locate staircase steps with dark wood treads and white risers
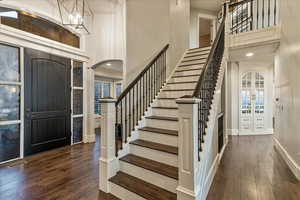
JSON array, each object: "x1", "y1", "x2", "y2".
[{"x1": 109, "y1": 47, "x2": 210, "y2": 200}]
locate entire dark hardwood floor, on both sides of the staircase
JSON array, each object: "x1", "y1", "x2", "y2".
[{"x1": 0, "y1": 132, "x2": 300, "y2": 200}]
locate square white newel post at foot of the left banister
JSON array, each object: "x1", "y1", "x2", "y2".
[{"x1": 99, "y1": 99, "x2": 117, "y2": 193}]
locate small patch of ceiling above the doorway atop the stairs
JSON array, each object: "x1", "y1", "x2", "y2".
[{"x1": 191, "y1": 0, "x2": 223, "y2": 12}]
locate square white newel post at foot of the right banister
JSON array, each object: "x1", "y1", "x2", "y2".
[{"x1": 176, "y1": 97, "x2": 200, "y2": 200}]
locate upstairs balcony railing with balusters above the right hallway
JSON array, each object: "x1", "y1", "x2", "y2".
[{"x1": 229, "y1": 0, "x2": 279, "y2": 34}]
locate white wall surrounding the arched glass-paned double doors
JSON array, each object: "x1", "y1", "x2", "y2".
[{"x1": 227, "y1": 61, "x2": 274, "y2": 135}]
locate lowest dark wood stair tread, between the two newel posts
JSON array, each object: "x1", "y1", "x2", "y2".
[{"x1": 109, "y1": 172, "x2": 177, "y2": 200}]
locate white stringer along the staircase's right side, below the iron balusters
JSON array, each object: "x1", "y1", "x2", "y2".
[{"x1": 196, "y1": 58, "x2": 227, "y2": 200}]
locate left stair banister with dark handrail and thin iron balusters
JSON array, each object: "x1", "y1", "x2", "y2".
[{"x1": 115, "y1": 45, "x2": 169, "y2": 155}]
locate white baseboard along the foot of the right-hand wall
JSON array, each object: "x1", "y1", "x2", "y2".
[{"x1": 273, "y1": 137, "x2": 300, "y2": 181}]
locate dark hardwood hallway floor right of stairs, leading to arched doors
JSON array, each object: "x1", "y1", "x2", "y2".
[{"x1": 207, "y1": 136, "x2": 300, "y2": 200}]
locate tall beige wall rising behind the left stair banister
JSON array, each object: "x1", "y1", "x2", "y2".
[{"x1": 125, "y1": 0, "x2": 190, "y2": 84}]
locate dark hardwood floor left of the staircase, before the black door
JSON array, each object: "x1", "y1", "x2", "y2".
[{"x1": 0, "y1": 133, "x2": 116, "y2": 200}]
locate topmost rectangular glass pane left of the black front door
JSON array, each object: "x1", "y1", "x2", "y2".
[{"x1": 0, "y1": 44, "x2": 20, "y2": 82}]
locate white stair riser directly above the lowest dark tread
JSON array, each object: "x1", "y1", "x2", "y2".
[{"x1": 120, "y1": 161, "x2": 178, "y2": 193}]
